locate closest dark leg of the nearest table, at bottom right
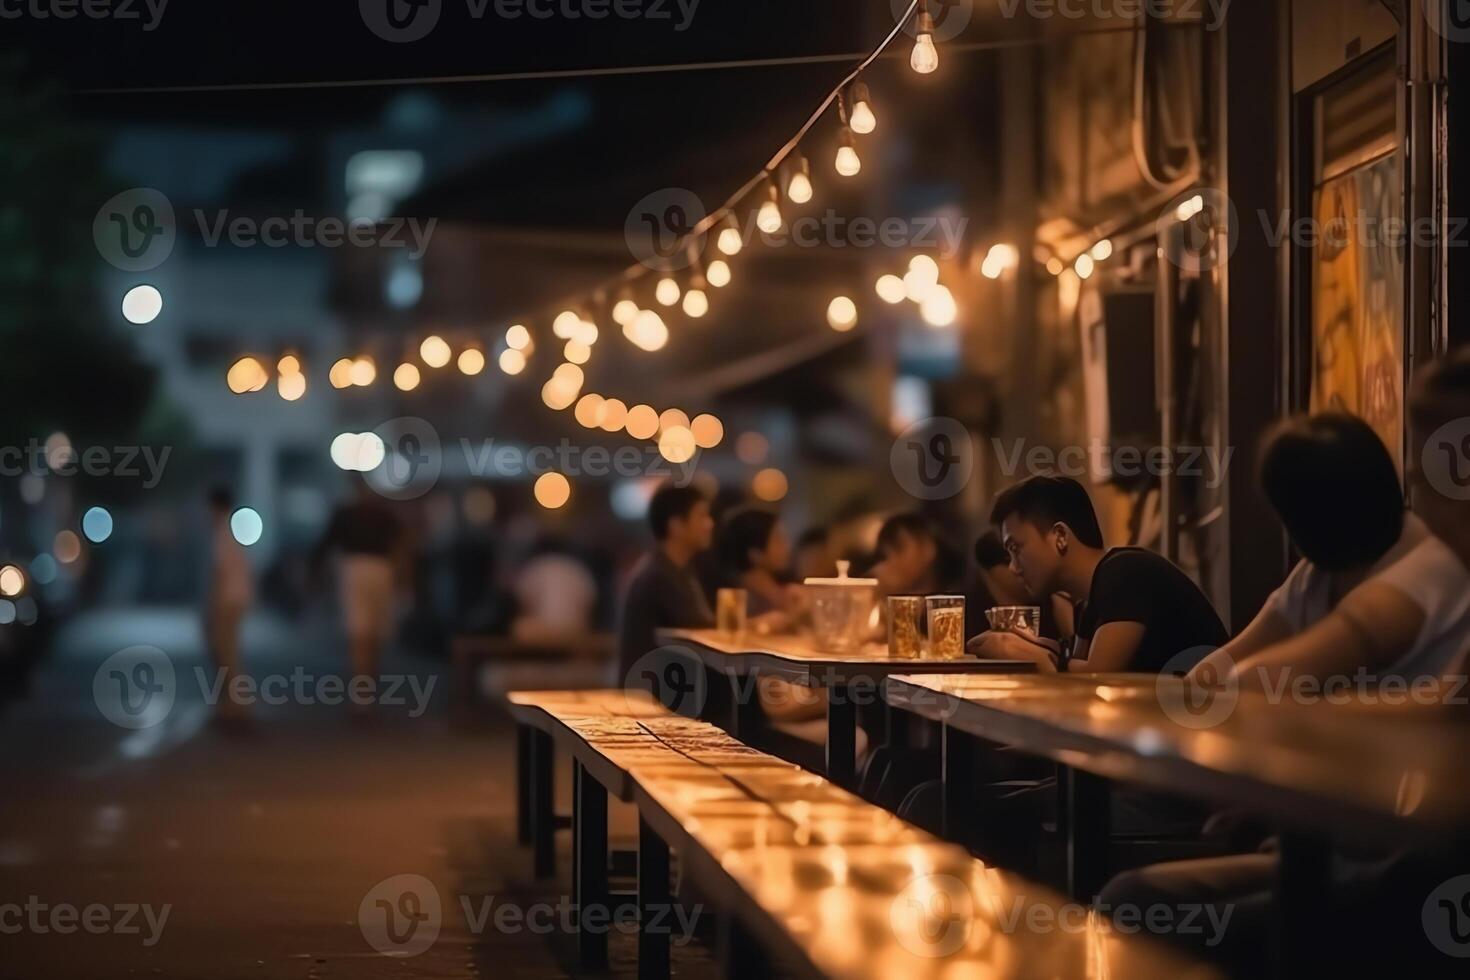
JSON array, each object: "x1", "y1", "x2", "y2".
[{"x1": 1274, "y1": 830, "x2": 1332, "y2": 977}]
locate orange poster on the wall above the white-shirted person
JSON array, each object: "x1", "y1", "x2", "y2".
[{"x1": 1311, "y1": 154, "x2": 1404, "y2": 469}]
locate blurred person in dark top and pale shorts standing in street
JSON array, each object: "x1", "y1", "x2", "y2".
[{"x1": 313, "y1": 479, "x2": 404, "y2": 705}]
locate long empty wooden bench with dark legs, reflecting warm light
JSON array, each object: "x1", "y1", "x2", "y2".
[{"x1": 512, "y1": 692, "x2": 1214, "y2": 980}]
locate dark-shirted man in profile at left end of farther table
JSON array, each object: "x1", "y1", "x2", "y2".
[{"x1": 617, "y1": 483, "x2": 714, "y2": 677}]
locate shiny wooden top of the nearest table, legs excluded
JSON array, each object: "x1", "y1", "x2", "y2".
[{"x1": 883, "y1": 674, "x2": 1470, "y2": 842}]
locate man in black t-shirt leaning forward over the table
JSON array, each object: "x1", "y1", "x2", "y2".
[{"x1": 970, "y1": 476, "x2": 1229, "y2": 673}]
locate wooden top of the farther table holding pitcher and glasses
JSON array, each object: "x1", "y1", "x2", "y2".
[{"x1": 659, "y1": 629, "x2": 1036, "y2": 688}]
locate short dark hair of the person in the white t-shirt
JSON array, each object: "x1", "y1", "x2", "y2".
[{"x1": 1258, "y1": 411, "x2": 1404, "y2": 570}]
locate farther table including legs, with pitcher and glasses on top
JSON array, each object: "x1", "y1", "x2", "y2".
[{"x1": 659, "y1": 629, "x2": 1035, "y2": 789}]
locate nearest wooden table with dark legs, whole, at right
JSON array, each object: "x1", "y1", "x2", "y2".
[{"x1": 883, "y1": 674, "x2": 1470, "y2": 973}]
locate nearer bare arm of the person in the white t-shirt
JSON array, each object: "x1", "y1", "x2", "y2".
[{"x1": 1233, "y1": 580, "x2": 1426, "y2": 689}]
